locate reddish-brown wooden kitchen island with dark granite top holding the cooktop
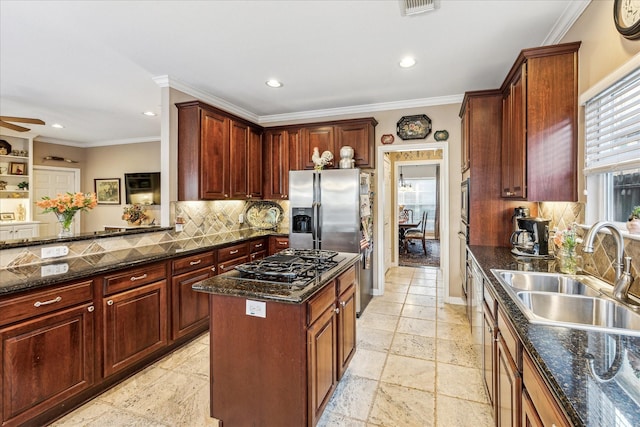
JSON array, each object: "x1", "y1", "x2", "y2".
[{"x1": 193, "y1": 253, "x2": 360, "y2": 426}]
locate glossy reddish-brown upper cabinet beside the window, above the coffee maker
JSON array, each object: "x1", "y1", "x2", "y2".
[{"x1": 501, "y1": 42, "x2": 580, "y2": 201}]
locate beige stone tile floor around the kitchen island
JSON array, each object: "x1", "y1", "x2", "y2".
[{"x1": 53, "y1": 267, "x2": 494, "y2": 427}]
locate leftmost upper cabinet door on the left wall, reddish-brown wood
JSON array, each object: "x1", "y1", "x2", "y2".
[{"x1": 200, "y1": 110, "x2": 231, "y2": 200}]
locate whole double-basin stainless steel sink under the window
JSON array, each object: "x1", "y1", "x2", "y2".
[{"x1": 491, "y1": 270, "x2": 640, "y2": 336}]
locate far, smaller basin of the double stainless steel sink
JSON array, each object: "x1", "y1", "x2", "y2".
[{"x1": 496, "y1": 270, "x2": 601, "y2": 296}]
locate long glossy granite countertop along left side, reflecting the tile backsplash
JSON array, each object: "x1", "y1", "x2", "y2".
[{"x1": 0, "y1": 229, "x2": 288, "y2": 296}]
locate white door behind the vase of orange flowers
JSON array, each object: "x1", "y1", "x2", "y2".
[{"x1": 33, "y1": 166, "x2": 81, "y2": 237}]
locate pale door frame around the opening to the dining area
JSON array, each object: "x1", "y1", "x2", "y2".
[{"x1": 374, "y1": 142, "x2": 449, "y2": 301}]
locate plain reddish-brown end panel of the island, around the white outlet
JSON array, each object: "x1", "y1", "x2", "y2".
[{"x1": 209, "y1": 295, "x2": 309, "y2": 427}]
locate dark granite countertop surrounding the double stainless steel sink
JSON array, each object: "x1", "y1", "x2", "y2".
[{"x1": 469, "y1": 246, "x2": 640, "y2": 427}]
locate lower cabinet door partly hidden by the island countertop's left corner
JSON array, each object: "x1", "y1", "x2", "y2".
[{"x1": 171, "y1": 267, "x2": 214, "y2": 340}]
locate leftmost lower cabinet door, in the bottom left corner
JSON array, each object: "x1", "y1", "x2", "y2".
[{"x1": 0, "y1": 303, "x2": 94, "y2": 425}]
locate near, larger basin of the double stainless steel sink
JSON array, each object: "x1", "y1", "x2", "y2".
[{"x1": 517, "y1": 292, "x2": 640, "y2": 335}]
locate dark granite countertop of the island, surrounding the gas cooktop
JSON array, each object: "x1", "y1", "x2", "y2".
[{"x1": 193, "y1": 252, "x2": 360, "y2": 304}]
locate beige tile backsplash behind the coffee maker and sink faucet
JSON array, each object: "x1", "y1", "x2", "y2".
[{"x1": 538, "y1": 202, "x2": 640, "y2": 298}]
